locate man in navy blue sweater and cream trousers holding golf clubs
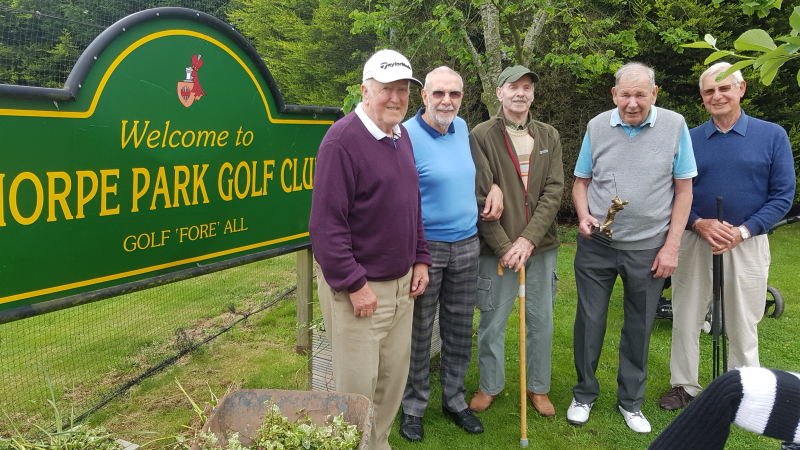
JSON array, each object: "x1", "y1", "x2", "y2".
[{"x1": 659, "y1": 63, "x2": 795, "y2": 410}]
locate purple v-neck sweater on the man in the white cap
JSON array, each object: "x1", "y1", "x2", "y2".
[{"x1": 308, "y1": 113, "x2": 431, "y2": 292}]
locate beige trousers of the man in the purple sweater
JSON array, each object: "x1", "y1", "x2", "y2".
[{"x1": 317, "y1": 270, "x2": 414, "y2": 450}]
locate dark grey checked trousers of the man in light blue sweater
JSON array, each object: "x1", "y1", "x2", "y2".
[{"x1": 403, "y1": 235, "x2": 480, "y2": 417}]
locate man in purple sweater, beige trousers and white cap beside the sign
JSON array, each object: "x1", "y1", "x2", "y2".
[{"x1": 308, "y1": 50, "x2": 431, "y2": 450}]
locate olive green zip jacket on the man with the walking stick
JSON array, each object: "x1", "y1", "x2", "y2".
[{"x1": 469, "y1": 111, "x2": 564, "y2": 257}]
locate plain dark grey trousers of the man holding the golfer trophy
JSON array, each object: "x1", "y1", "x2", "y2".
[{"x1": 572, "y1": 236, "x2": 664, "y2": 412}]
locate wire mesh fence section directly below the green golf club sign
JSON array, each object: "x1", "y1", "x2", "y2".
[{"x1": 0, "y1": 254, "x2": 296, "y2": 435}]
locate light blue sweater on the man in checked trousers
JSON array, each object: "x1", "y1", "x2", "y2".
[{"x1": 403, "y1": 108, "x2": 478, "y2": 242}]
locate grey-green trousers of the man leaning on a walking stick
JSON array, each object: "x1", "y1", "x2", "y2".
[{"x1": 478, "y1": 249, "x2": 558, "y2": 395}]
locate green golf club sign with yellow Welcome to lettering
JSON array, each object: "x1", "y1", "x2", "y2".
[{"x1": 0, "y1": 8, "x2": 338, "y2": 311}]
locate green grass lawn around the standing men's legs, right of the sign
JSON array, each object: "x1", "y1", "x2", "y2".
[{"x1": 389, "y1": 226, "x2": 800, "y2": 450}]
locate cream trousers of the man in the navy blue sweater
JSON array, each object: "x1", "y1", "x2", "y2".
[{"x1": 669, "y1": 231, "x2": 770, "y2": 396}]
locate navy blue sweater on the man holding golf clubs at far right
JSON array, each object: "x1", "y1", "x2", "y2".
[{"x1": 686, "y1": 111, "x2": 795, "y2": 236}]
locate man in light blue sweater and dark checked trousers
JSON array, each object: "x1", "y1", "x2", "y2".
[{"x1": 400, "y1": 66, "x2": 502, "y2": 442}]
